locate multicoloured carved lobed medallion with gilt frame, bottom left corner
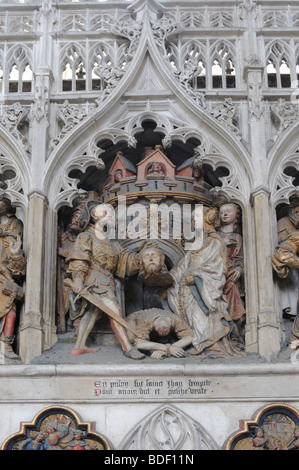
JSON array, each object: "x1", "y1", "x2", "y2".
[{"x1": 0, "y1": 406, "x2": 112, "y2": 450}]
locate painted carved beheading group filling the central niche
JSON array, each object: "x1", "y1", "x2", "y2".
[{"x1": 52, "y1": 151, "x2": 245, "y2": 359}]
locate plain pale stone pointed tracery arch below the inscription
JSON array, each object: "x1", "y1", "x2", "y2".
[{"x1": 120, "y1": 405, "x2": 218, "y2": 451}]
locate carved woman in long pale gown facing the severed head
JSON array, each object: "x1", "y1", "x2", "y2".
[{"x1": 168, "y1": 209, "x2": 242, "y2": 356}]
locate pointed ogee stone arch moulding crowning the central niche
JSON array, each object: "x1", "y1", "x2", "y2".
[{"x1": 45, "y1": 1, "x2": 254, "y2": 201}]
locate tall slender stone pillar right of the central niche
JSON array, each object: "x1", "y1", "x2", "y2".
[{"x1": 244, "y1": 10, "x2": 281, "y2": 360}]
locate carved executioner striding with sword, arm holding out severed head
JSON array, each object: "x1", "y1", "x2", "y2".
[{"x1": 65, "y1": 201, "x2": 144, "y2": 359}]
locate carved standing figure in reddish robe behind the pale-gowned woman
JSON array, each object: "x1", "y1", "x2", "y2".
[{"x1": 218, "y1": 204, "x2": 245, "y2": 339}]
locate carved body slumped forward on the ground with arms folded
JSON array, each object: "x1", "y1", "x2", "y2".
[{"x1": 128, "y1": 308, "x2": 194, "y2": 359}]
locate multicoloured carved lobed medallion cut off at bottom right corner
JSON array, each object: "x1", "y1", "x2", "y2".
[{"x1": 222, "y1": 403, "x2": 299, "y2": 450}]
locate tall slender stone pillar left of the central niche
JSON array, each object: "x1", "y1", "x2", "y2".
[{"x1": 19, "y1": 0, "x2": 56, "y2": 363}]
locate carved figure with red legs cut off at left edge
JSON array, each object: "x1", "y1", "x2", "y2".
[{"x1": 0, "y1": 196, "x2": 26, "y2": 359}]
